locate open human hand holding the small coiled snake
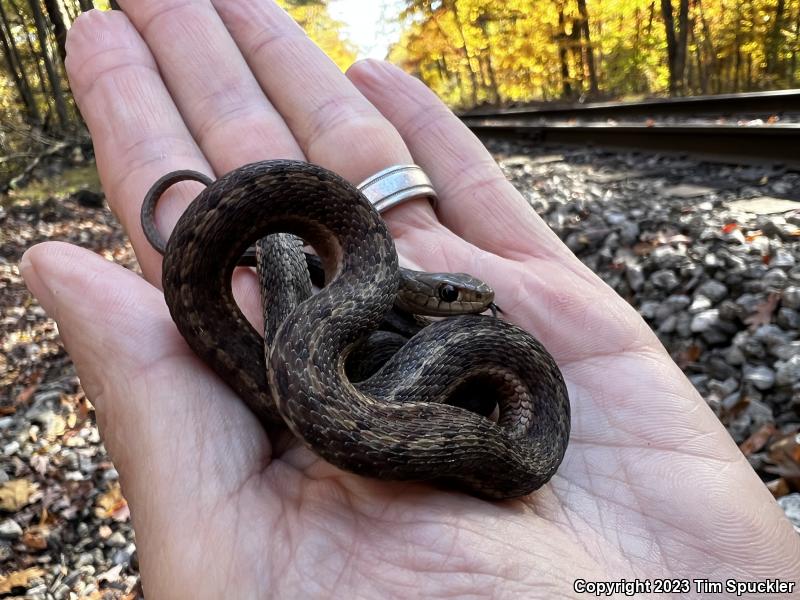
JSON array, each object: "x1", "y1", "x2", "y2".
[{"x1": 22, "y1": 0, "x2": 800, "y2": 598}]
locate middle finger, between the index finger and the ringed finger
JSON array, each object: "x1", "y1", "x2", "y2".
[{"x1": 120, "y1": 0, "x2": 303, "y2": 174}]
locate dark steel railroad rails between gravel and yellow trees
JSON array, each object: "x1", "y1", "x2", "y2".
[{"x1": 462, "y1": 90, "x2": 800, "y2": 169}]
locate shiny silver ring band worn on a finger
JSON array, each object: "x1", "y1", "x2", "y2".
[{"x1": 358, "y1": 165, "x2": 438, "y2": 213}]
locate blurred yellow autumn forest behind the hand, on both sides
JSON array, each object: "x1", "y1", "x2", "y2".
[{"x1": 0, "y1": 0, "x2": 800, "y2": 193}]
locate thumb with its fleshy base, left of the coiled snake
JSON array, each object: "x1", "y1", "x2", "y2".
[{"x1": 20, "y1": 242, "x2": 269, "y2": 548}]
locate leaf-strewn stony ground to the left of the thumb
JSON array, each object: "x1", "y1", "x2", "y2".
[{"x1": 0, "y1": 166, "x2": 139, "y2": 600}]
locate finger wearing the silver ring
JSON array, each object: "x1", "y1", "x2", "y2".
[{"x1": 213, "y1": 0, "x2": 435, "y2": 230}]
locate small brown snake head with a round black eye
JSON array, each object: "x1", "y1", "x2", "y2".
[{"x1": 395, "y1": 271, "x2": 494, "y2": 317}]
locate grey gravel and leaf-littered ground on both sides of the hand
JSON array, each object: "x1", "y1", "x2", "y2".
[{"x1": 0, "y1": 142, "x2": 800, "y2": 600}]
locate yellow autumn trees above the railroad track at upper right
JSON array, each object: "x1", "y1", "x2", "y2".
[{"x1": 390, "y1": 0, "x2": 800, "y2": 107}]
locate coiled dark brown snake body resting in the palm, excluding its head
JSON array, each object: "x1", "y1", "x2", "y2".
[{"x1": 142, "y1": 160, "x2": 570, "y2": 500}]
